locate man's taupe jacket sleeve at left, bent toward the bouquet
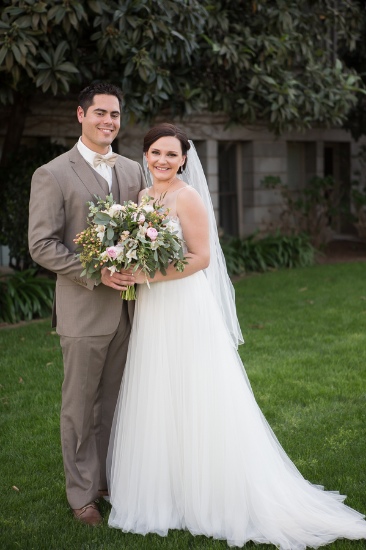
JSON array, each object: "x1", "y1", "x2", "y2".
[{"x1": 28, "y1": 166, "x2": 94, "y2": 290}]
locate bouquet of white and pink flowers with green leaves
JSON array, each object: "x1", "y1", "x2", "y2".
[{"x1": 74, "y1": 194, "x2": 187, "y2": 300}]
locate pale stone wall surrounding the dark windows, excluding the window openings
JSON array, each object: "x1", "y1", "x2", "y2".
[{"x1": 0, "y1": 97, "x2": 366, "y2": 250}]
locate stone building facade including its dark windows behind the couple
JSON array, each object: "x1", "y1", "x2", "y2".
[{"x1": 0, "y1": 99, "x2": 366, "y2": 265}]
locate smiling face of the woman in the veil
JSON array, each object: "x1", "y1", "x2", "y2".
[{"x1": 146, "y1": 136, "x2": 185, "y2": 183}]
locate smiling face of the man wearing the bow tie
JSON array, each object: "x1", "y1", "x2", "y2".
[{"x1": 77, "y1": 94, "x2": 121, "y2": 155}]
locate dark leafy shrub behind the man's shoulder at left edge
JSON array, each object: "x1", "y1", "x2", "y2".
[{"x1": 0, "y1": 140, "x2": 67, "y2": 270}]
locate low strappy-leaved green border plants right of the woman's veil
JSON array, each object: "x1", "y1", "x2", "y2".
[{"x1": 221, "y1": 233, "x2": 315, "y2": 276}]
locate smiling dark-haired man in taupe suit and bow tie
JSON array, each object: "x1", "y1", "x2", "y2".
[{"x1": 29, "y1": 83, "x2": 145, "y2": 525}]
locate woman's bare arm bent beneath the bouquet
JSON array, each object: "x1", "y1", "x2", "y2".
[{"x1": 135, "y1": 187, "x2": 210, "y2": 283}]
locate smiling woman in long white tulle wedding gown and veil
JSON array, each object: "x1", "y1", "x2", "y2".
[{"x1": 108, "y1": 124, "x2": 366, "y2": 550}]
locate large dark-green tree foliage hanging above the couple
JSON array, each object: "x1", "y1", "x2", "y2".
[{"x1": 0, "y1": 0, "x2": 366, "y2": 170}]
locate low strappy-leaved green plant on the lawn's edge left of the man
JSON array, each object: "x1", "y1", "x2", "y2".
[{"x1": 0, "y1": 269, "x2": 55, "y2": 323}]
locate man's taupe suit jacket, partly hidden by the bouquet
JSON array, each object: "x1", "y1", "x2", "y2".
[{"x1": 29, "y1": 145, "x2": 145, "y2": 337}]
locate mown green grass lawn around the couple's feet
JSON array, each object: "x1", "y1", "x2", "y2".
[{"x1": 0, "y1": 263, "x2": 366, "y2": 550}]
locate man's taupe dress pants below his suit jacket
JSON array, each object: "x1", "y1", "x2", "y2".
[{"x1": 60, "y1": 302, "x2": 131, "y2": 508}]
